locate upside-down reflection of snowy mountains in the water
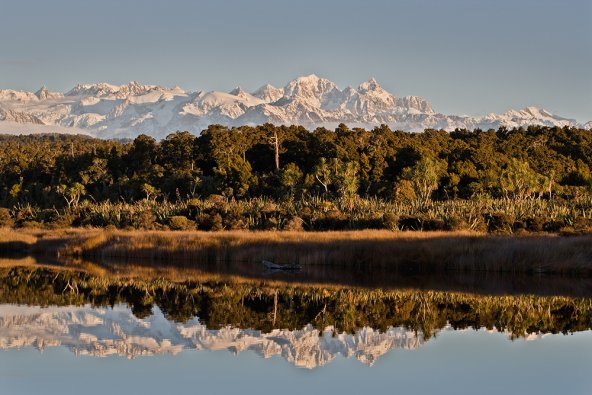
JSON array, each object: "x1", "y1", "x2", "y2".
[{"x1": 0, "y1": 304, "x2": 424, "y2": 369}]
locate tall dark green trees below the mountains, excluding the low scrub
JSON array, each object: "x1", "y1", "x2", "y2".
[{"x1": 0, "y1": 124, "x2": 592, "y2": 232}]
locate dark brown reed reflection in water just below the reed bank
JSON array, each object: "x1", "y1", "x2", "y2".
[{"x1": 0, "y1": 256, "x2": 592, "y2": 297}]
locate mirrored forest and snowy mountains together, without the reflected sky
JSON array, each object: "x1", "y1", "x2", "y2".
[{"x1": 0, "y1": 266, "x2": 592, "y2": 368}]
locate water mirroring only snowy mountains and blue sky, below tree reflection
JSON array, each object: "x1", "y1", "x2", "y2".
[{"x1": 0, "y1": 305, "x2": 592, "y2": 394}]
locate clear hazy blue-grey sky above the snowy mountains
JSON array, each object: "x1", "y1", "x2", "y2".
[{"x1": 0, "y1": 0, "x2": 592, "y2": 121}]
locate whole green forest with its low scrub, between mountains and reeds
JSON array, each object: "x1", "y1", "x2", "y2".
[{"x1": 0, "y1": 124, "x2": 592, "y2": 233}]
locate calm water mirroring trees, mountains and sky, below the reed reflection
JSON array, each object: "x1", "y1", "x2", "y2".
[{"x1": 0, "y1": 262, "x2": 592, "y2": 394}]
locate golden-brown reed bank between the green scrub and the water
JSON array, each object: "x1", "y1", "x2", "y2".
[{"x1": 0, "y1": 229, "x2": 592, "y2": 276}]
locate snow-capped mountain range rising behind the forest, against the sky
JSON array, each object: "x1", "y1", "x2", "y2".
[{"x1": 0, "y1": 74, "x2": 592, "y2": 138}]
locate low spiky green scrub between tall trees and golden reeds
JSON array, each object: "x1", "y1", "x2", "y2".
[{"x1": 0, "y1": 195, "x2": 592, "y2": 235}]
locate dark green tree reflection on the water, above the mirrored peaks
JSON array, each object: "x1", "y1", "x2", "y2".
[{"x1": 0, "y1": 267, "x2": 592, "y2": 339}]
